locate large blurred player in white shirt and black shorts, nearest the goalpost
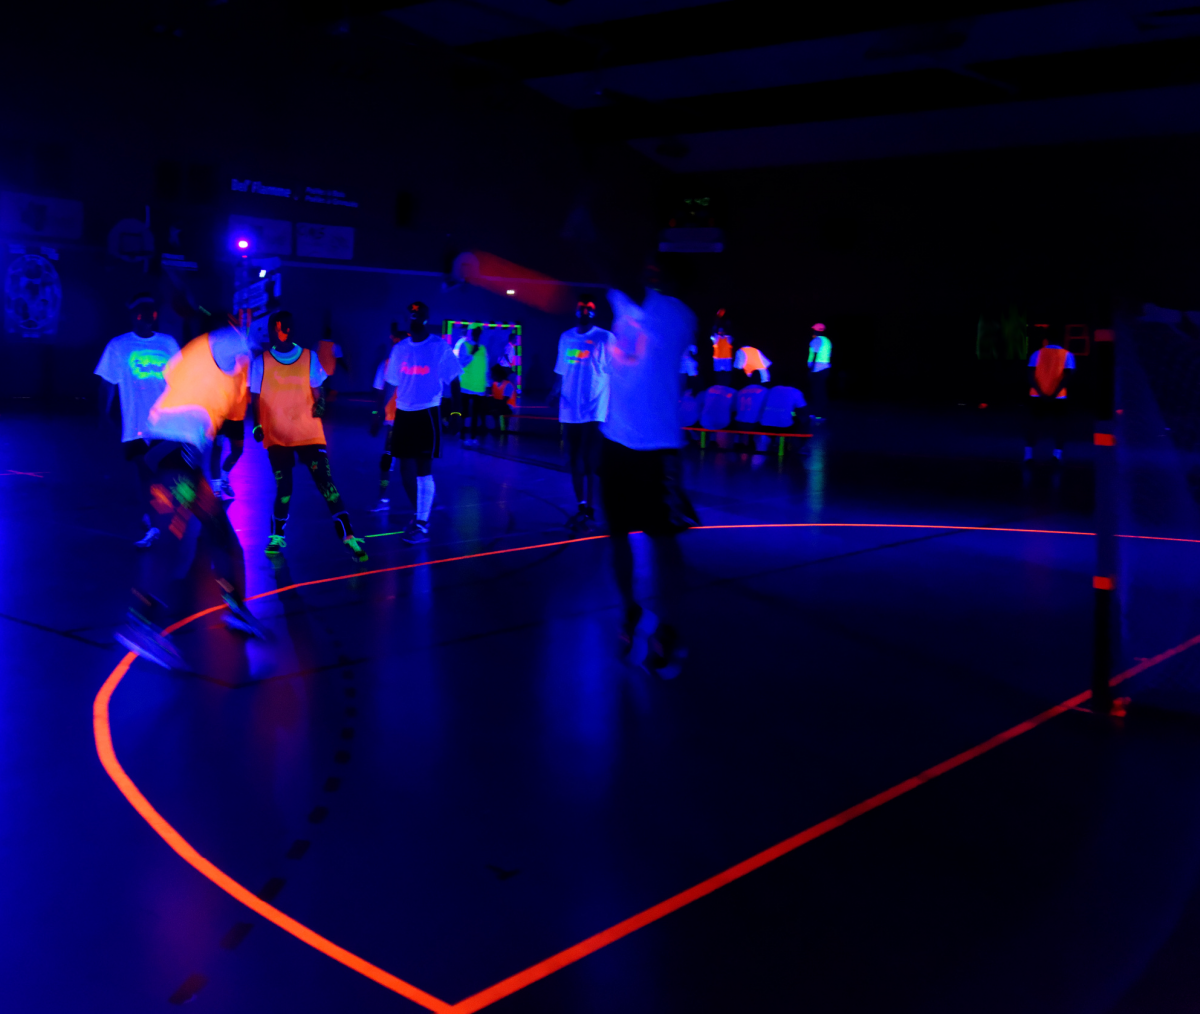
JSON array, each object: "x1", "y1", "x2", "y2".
[{"x1": 600, "y1": 255, "x2": 698, "y2": 679}]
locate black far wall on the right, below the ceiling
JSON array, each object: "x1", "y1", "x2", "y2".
[{"x1": 686, "y1": 129, "x2": 1200, "y2": 403}]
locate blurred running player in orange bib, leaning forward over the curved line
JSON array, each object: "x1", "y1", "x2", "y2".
[{"x1": 114, "y1": 307, "x2": 265, "y2": 668}]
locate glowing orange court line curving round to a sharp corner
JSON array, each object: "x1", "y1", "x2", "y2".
[{"x1": 92, "y1": 522, "x2": 1200, "y2": 1014}]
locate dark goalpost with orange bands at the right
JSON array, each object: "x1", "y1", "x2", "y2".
[{"x1": 1092, "y1": 330, "x2": 1117, "y2": 715}]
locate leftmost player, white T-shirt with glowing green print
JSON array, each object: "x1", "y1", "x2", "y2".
[{"x1": 95, "y1": 293, "x2": 179, "y2": 550}]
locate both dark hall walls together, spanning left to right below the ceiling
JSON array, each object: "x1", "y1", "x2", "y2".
[{"x1": 7, "y1": 0, "x2": 1200, "y2": 403}]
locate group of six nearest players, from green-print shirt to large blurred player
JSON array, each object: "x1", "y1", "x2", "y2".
[{"x1": 96, "y1": 265, "x2": 696, "y2": 678}]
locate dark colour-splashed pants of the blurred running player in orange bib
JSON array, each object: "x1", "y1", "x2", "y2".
[{"x1": 134, "y1": 444, "x2": 246, "y2": 625}]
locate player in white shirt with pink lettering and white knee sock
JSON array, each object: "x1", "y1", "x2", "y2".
[{"x1": 371, "y1": 302, "x2": 462, "y2": 544}]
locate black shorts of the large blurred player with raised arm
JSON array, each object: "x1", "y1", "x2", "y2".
[{"x1": 600, "y1": 437, "x2": 700, "y2": 535}]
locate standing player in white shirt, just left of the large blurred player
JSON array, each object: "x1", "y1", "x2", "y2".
[{"x1": 550, "y1": 294, "x2": 612, "y2": 530}]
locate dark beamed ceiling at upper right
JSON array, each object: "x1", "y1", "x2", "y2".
[{"x1": 388, "y1": 0, "x2": 1200, "y2": 170}]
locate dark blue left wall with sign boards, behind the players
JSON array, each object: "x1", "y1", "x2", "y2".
[{"x1": 0, "y1": 2, "x2": 661, "y2": 407}]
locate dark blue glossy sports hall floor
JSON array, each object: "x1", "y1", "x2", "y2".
[{"x1": 7, "y1": 409, "x2": 1200, "y2": 1014}]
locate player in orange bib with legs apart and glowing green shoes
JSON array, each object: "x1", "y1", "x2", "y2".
[{"x1": 250, "y1": 310, "x2": 367, "y2": 563}]
